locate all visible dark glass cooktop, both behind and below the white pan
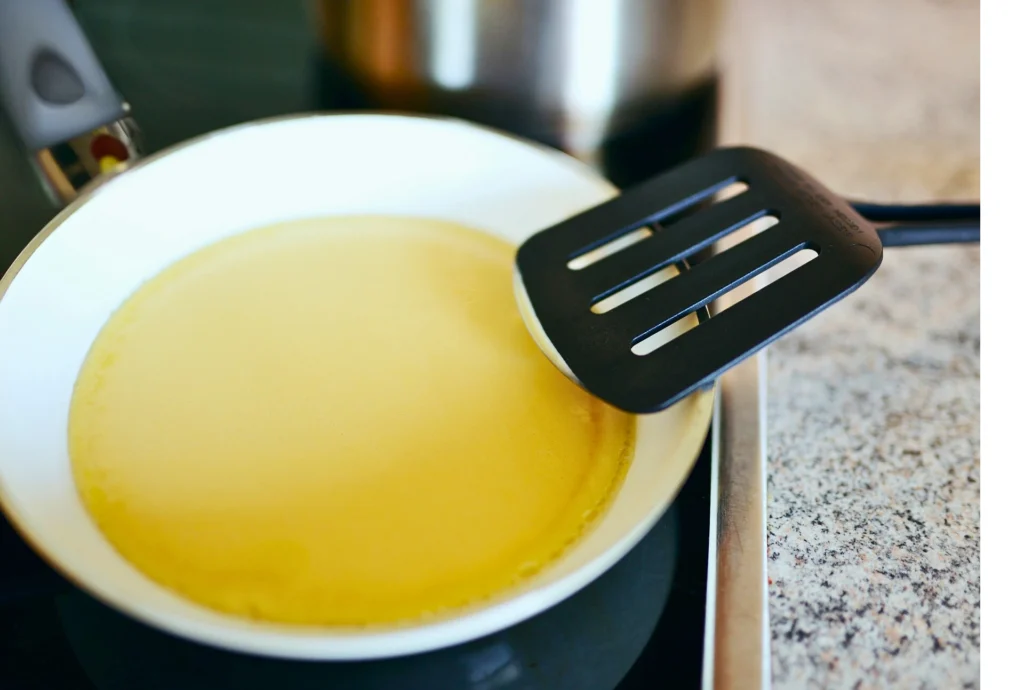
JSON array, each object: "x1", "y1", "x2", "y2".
[{"x1": 0, "y1": 0, "x2": 717, "y2": 690}]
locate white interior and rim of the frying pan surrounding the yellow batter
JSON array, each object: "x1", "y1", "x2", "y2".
[{"x1": 0, "y1": 0, "x2": 713, "y2": 659}]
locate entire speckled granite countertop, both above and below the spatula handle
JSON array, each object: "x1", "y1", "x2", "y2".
[{"x1": 727, "y1": 0, "x2": 981, "y2": 690}]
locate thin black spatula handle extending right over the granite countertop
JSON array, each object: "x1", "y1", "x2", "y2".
[{"x1": 852, "y1": 202, "x2": 981, "y2": 247}]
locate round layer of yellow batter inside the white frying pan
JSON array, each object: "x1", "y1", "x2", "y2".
[{"x1": 69, "y1": 217, "x2": 634, "y2": 624}]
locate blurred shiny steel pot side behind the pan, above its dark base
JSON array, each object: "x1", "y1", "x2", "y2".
[{"x1": 315, "y1": 0, "x2": 719, "y2": 160}]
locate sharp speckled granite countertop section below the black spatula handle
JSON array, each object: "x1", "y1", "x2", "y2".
[{"x1": 768, "y1": 243, "x2": 981, "y2": 688}]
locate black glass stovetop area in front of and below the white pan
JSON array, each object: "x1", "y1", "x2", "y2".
[{"x1": 0, "y1": 436, "x2": 712, "y2": 690}]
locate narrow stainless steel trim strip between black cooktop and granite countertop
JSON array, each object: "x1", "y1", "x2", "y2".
[{"x1": 706, "y1": 0, "x2": 771, "y2": 690}]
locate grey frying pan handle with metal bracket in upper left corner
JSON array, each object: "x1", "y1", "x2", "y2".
[{"x1": 0, "y1": 0, "x2": 141, "y2": 204}]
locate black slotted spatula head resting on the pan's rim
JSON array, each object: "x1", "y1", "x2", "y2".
[{"x1": 516, "y1": 147, "x2": 882, "y2": 414}]
